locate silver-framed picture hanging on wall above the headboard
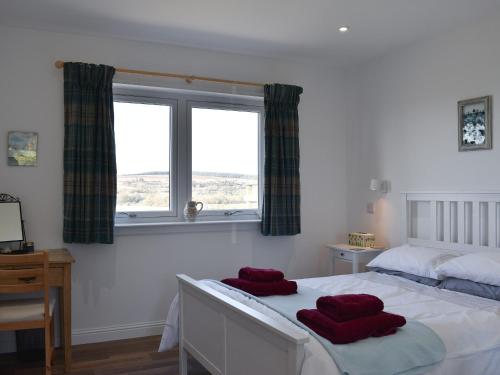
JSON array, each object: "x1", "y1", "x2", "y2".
[{"x1": 458, "y1": 96, "x2": 492, "y2": 151}]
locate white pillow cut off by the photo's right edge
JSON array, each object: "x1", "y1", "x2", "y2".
[{"x1": 436, "y1": 250, "x2": 500, "y2": 286}]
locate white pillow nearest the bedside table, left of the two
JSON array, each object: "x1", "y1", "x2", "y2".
[{"x1": 367, "y1": 245, "x2": 458, "y2": 280}]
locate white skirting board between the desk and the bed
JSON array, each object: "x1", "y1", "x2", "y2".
[{"x1": 72, "y1": 320, "x2": 165, "y2": 345}]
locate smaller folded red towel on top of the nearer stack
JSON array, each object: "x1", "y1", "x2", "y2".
[{"x1": 316, "y1": 294, "x2": 384, "y2": 322}]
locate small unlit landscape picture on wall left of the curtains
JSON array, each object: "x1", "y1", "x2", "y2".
[{"x1": 7, "y1": 131, "x2": 38, "y2": 167}]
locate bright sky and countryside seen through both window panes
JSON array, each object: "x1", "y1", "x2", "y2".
[{"x1": 114, "y1": 102, "x2": 259, "y2": 212}]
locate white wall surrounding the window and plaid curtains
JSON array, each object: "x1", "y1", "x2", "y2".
[{"x1": 0, "y1": 28, "x2": 347, "y2": 348}]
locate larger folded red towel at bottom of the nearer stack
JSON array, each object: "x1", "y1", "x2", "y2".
[{"x1": 297, "y1": 310, "x2": 406, "y2": 344}]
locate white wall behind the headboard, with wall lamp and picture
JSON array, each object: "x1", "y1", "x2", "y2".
[{"x1": 347, "y1": 17, "x2": 500, "y2": 245}]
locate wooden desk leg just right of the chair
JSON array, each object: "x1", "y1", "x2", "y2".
[{"x1": 59, "y1": 265, "x2": 71, "y2": 372}]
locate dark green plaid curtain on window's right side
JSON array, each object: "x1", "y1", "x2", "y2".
[{"x1": 261, "y1": 84, "x2": 302, "y2": 236}]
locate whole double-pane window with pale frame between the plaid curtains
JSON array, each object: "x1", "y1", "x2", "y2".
[{"x1": 114, "y1": 85, "x2": 263, "y2": 224}]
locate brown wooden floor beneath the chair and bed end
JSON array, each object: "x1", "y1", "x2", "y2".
[{"x1": 0, "y1": 336, "x2": 209, "y2": 375}]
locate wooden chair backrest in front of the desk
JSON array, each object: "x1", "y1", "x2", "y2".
[{"x1": 0, "y1": 251, "x2": 49, "y2": 296}]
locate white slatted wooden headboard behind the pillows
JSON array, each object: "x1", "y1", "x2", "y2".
[{"x1": 401, "y1": 192, "x2": 500, "y2": 251}]
